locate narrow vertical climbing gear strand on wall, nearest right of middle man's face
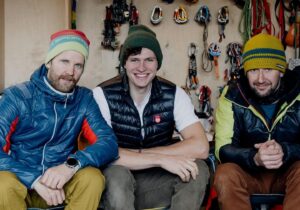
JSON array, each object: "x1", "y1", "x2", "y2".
[{"x1": 186, "y1": 43, "x2": 199, "y2": 90}]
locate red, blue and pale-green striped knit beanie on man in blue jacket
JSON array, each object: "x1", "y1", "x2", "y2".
[{"x1": 45, "y1": 29, "x2": 90, "y2": 64}]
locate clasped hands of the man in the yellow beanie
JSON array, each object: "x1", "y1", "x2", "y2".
[{"x1": 254, "y1": 140, "x2": 284, "y2": 169}]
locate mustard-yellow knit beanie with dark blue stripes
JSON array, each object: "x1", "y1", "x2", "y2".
[{"x1": 243, "y1": 33, "x2": 287, "y2": 73}]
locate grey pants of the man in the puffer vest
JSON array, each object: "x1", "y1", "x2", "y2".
[{"x1": 102, "y1": 160, "x2": 209, "y2": 210}]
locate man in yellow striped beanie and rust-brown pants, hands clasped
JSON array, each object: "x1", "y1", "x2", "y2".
[{"x1": 214, "y1": 34, "x2": 300, "y2": 210}]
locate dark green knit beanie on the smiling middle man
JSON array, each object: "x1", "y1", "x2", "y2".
[{"x1": 119, "y1": 25, "x2": 163, "y2": 70}]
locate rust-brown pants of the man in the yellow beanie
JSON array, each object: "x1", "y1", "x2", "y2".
[{"x1": 214, "y1": 161, "x2": 300, "y2": 210}]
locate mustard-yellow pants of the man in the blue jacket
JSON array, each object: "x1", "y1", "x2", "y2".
[{"x1": 0, "y1": 167, "x2": 105, "y2": 210}]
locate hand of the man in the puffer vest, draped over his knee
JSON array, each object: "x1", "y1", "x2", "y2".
[{"x1": 160, "y1": 155, "x2": 199, "y2": 182}]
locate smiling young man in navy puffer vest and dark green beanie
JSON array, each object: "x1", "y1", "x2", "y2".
[{"x1": 94, "y1": 25, "x2": 209, "y2": 210}]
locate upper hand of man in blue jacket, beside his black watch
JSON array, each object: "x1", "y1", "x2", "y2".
[{"x1": 40, "y1": 164, "x2": 76, "y2": 189}]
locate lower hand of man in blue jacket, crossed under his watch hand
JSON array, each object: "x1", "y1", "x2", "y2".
[{"x1": 34, "y1": 181, "x2": 65, "y2": 206}]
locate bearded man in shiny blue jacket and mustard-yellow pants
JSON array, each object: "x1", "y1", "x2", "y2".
[{"x1": 0, "y1": 30, "x2": 118, "y2": 210}]
